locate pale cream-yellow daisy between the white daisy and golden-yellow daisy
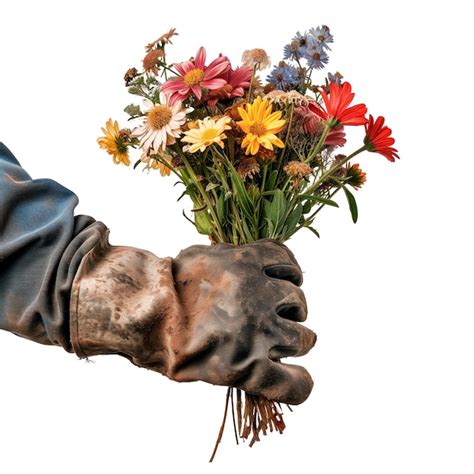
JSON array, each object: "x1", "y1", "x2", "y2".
[{"x1": 181, "y1": 116, "x2": 231, "y2": 153}]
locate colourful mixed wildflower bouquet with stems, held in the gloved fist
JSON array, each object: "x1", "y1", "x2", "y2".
[{"x1": 98, "y1": 26, "x2": 398, "y2": 460}]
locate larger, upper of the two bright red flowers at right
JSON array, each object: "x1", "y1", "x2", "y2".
[{"x1": 309, "y1": 82, "x2": 367, "y2": 128}]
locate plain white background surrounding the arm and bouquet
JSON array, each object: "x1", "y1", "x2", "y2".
[{"x1": 0, "y1": 0, "x2": 474, "y2": 474}]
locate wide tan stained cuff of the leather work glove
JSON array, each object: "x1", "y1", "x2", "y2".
[{"x1": 70, "y1": 231, "x2": 179, "y2": 373}]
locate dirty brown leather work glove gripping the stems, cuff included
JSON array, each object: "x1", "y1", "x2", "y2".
[{"x1": 70, "y1": 233, "x2": 316, "y2": 404}]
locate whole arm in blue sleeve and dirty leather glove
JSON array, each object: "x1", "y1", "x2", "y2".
[{"x1": 0, "y1": 144, "x2": 316, "y2": 404}]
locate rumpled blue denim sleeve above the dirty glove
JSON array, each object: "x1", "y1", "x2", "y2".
[{"x1": 0, "y1": 143, "x2": 107, "y2": 352}]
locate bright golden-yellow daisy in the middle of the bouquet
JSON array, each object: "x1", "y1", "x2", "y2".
[{"x1": 237, "y1": 96, "x2": 285, "y2": 155}]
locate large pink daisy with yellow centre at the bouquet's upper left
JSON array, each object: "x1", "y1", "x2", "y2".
[{"x1": 161, "y1": 46, "x2": 230, "y2": 104}]
